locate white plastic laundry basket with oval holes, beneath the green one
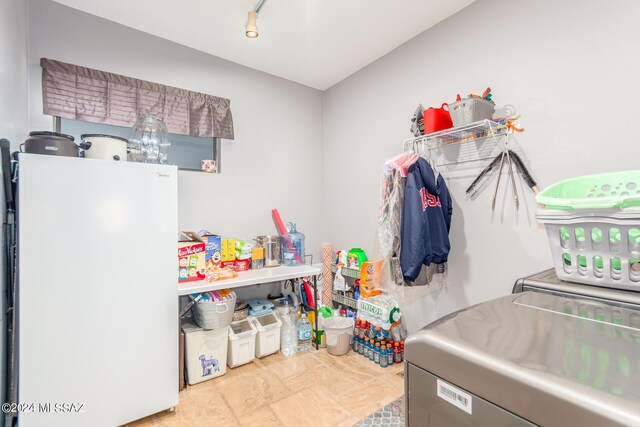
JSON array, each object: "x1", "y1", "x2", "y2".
[{"x1": 536, "y1": 208, "x2": 640, "y2": 291}]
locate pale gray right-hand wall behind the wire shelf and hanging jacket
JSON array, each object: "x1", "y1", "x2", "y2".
[{"x1": 324, "y1": 0, "x2": 640, "y2": 329}]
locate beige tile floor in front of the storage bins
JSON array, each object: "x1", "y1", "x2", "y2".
[{"x1": 127, "y1": 349, "x2": 404, "y2": 427}]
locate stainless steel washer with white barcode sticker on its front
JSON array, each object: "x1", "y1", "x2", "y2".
[{"x1": 405, "y1": 270, "x2": 640, "y2": 427}]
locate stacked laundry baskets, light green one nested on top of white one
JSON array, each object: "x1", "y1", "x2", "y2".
[{"x1": 536, "y1": 171, "x2": 640, "y2": 291}]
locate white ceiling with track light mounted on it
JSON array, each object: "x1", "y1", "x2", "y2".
[{"x1": 50, "y1": 0, "x2": 475, "y2": 90}]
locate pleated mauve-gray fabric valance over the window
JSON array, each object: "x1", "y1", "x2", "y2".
[{"x1": 40, "y1": 58, "x2": 233, "y2": 139}]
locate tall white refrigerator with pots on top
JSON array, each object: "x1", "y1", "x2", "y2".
[{"x1": 17, "y1": 154, "x2": 178, "y2": 427}]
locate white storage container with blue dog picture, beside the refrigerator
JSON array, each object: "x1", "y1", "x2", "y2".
[{"x1": 182, "y1": 320, "x2": 229, "y2": 384}]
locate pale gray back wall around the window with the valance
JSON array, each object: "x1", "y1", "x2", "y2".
[{"x1": 29, "y1": 0, "x2": 324, "y2": 259}]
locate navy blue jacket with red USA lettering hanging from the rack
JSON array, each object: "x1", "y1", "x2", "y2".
[{"x1": 400, "y1": 158, "x2": 452, "y2": 281}]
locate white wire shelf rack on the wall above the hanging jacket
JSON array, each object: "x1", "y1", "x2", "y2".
[{"x1": 404, "y1": 120, "x2": 509, "y2": 166}]
